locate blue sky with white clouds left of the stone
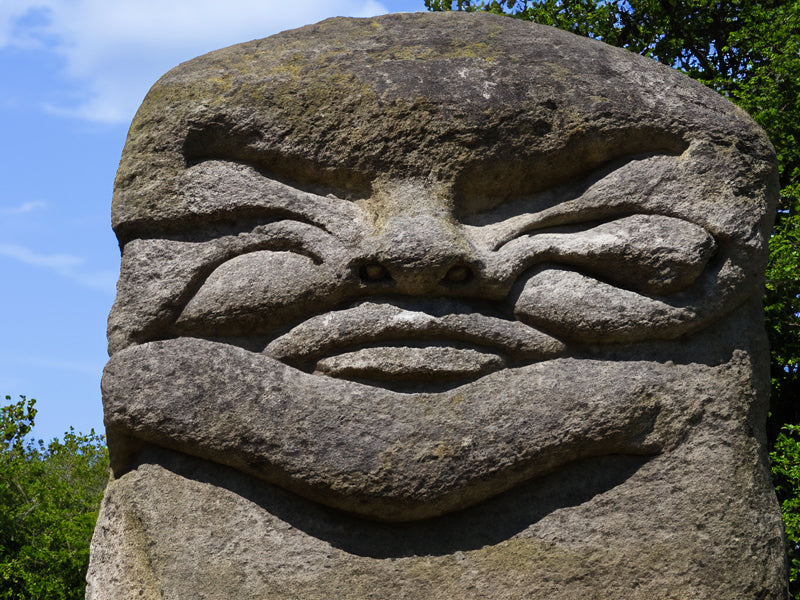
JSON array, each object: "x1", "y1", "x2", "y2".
[{"x1": 0, "y1": 0, "x2": 425, "y2": 440}]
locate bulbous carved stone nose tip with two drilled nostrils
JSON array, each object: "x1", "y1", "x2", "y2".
[{"x1": 359, "y1": 215, "x2": 477, "y2": 294}]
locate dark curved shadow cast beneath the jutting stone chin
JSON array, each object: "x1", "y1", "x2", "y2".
[{"x1": 139, "y1": 447, "x2": 650, "y2": 559}]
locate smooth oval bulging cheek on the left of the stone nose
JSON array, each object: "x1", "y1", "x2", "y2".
[{"x1": 176, "y1": 250, "x2": 346, "y2": 335}]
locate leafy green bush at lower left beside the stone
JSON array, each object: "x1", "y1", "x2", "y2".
[{"x1": 0, "y1": 396, "x2": 108, "y2": 600}]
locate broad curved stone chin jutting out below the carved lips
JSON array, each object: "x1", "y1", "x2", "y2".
[{"x1": 103, "y1": 338, "x2": 687, "y2": 521}]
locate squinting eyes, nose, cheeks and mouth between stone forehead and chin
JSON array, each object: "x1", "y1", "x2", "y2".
[{"x1": 165, "y1": 154, "x2": 720, "y2": 380}]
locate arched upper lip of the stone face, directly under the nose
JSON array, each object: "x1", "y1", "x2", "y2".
[{"x1": 264, "y1": 299, "x2": 565, "y2": 363}]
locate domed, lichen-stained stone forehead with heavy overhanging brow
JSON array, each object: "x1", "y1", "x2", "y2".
[{"x1": 112, "y1": 13, "x2": 770, "y2": 232}]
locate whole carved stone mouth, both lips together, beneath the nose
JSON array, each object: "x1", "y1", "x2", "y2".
[{"x1": 264, "y1": 299, "x2": 565, "y2": 380}]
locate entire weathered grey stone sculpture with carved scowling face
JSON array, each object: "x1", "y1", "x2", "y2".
[{"x1": 87, "y1": 13, "x2": 786, "y2": 600}]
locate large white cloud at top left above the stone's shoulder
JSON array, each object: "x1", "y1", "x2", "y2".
[{"x1": 0, "y1": 0, "x2": 387, "y2": 122}]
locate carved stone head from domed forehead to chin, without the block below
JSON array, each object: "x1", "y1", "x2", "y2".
[{"x1": 104, "y1": 15, "x2": 774, "y2": 520}]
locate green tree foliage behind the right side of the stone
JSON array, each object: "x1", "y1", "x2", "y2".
[{"x1": 432, "y1": 0, "x2": 800, "y2": 600}]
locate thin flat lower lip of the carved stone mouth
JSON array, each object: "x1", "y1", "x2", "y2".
[{"x1": 315, "y1": 346, "x2": 507, "y2": 381}]
